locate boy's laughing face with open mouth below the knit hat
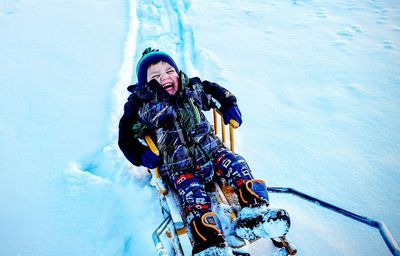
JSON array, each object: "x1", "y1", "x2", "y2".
[{"x1": 147, "y1": 61, "x2": 179, "y2": 95}]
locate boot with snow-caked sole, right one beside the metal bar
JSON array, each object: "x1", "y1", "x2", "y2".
[{"x1": 235, "y1": 180, "x2": 290, "y2": 241}]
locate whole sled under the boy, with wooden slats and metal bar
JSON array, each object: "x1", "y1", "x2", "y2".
[{"x1": 145, "y1": 110, "x2": 400, "y2": 256}]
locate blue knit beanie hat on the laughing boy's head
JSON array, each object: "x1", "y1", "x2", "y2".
[{"x1": 136, "y1": 47, "x2": 179, "y2": 84}]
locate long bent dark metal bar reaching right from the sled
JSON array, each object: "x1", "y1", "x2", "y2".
[{"x1": 268, "y1": 187, "x2": 400, "y2": 256}]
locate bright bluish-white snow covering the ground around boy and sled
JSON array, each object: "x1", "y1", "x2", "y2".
[{"x1": 0, "y1": 0, "x2": 400, "y2": 255}]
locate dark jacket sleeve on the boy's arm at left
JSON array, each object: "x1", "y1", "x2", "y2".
[{"x1": 118, "y1": 95, "x2": 147, "y2": 166}]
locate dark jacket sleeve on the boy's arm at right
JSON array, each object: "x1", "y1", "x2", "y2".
[{"x1": 196, "y1": 78, "x2": 237, "y2": 112}]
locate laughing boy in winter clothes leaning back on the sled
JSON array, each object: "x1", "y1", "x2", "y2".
[{"x1": 118, "y1": 48, "x2": 290, "y2": 255}]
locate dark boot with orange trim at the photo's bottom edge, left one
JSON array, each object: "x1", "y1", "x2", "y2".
[{"x1": 190, "y1": 212, "x2": 231, "y2": 256}]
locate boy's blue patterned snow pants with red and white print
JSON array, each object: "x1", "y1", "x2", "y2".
[{"x1": 170, "y1": 148, "x2": 253, "y2": 222}]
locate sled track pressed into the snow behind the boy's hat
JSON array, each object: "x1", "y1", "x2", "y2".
[{"x1": 133, "y1": 0, "x2": 226, "y2": 82}]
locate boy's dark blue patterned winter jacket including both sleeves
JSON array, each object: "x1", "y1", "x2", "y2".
[{"x1": 118, "y1": 72, "x2": 236, "y2": 173}]
